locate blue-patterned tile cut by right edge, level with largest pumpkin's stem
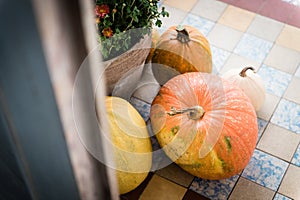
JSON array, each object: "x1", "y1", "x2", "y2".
[{"x1": 271, "y1": 99, "x2": 300, "y2": 134}]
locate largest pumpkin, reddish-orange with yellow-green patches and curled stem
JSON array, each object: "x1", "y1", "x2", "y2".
[{"x1": 150, "y1": 72, "x2": 258, "y2": 180}]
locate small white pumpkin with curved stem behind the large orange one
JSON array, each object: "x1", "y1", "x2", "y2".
[{"x1": 222, "y1": 67, "x2": 266, "y2": 111}]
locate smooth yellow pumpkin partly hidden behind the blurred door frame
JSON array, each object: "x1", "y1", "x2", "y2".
[{"x1": 105, "y1": 97, "x2": 152, "y2": 194}]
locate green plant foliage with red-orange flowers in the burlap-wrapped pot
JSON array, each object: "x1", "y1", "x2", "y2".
[{"x1": 95, "y1": 0, "x2": 169, "y2": 60}]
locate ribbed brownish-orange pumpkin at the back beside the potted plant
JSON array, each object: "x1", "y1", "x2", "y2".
[{"x1": 152, "y1": 25, "x2": 212, "y2": 73}]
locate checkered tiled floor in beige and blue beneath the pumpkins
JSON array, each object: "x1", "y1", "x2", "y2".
[{"x1": 121, "y1": 0, "x2": 300, "y2": 200}]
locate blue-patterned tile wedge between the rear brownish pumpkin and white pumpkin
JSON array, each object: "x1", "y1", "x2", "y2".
[{"x1": 210, "y1": 45, "x2": 230, "y2": 74}]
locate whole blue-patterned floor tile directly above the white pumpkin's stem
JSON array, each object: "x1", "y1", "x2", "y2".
[{"x1": 234, "y1": 33, "x2": 273, "y2": 63}]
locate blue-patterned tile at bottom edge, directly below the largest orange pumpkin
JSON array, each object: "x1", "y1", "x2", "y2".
[{"x1": 190, "y1": 175, "x2": 239, "y2": 200}]
